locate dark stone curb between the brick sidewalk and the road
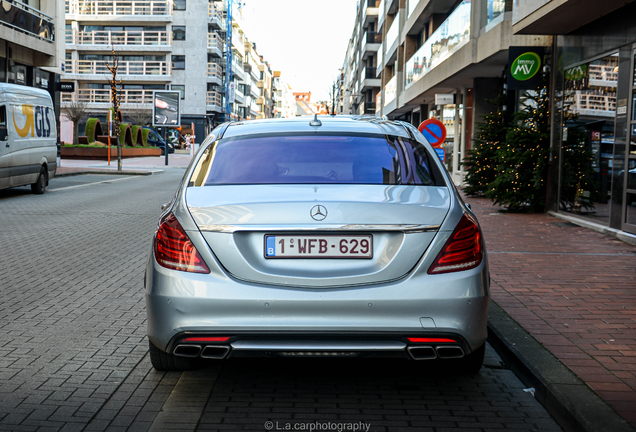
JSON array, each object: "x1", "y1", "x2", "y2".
[{"x1": 488, "y1": 301, "x2": 635, "y2": 432}]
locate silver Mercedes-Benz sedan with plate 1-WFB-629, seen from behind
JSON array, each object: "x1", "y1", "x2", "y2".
[{"x1": 145, "y1": 116, "x2": 489, "y2": 372}]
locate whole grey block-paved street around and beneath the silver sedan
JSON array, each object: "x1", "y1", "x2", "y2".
[{"x1": 0, "y1": 170, "x2": 560, "y2": 432}]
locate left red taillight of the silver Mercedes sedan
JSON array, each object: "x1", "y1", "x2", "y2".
[{"x1": 155, "y1": 213, "x2": 210, "y2": 273}]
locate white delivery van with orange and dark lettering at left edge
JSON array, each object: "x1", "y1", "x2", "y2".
[{"x1": 0, "y1": 83, "x2": 57, "y2": 194}]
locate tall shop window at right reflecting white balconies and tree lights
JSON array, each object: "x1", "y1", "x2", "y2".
[{"x1": 559, "y1": 54, "x2": 618, "y2": 224}]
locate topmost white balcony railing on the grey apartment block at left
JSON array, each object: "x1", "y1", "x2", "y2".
[{"x1": 66, "y1": 0, "x2": 172, "y2": 16}]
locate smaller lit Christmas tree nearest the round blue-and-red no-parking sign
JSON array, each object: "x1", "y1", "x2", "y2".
[{"x1": 463, "y1": 94, "x2": 506, "y2": 196}]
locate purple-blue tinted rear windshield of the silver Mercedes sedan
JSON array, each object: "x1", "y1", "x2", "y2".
[{"x1": 190, "y1": 134, "x2": 444, "y2": 186}]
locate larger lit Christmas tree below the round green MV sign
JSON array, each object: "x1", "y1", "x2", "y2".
[{"x1": 486, "y1": 81, "x2": 550, "y2": 212}]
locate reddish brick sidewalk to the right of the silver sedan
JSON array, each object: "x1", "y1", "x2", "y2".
[{"x1": 465, "y1": 194, "x2": 636, "y2": 426}]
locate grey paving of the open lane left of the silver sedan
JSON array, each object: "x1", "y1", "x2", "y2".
[{"x1": 0, "y1": 171, "x2": 183, "y2": 431}]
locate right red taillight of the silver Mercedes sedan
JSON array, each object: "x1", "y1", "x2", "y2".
[{"x1": 428, "y1": 213, "x2": 484, "y2": 274}]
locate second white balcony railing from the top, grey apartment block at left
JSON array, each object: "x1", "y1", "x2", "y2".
[{"x1": 66, "y1": 30, "x2": 172, "y2": 46}]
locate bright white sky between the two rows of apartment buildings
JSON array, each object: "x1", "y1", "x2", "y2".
[{"x1": 240, "y1": 0, "x2": 358, "y2": 102}]
